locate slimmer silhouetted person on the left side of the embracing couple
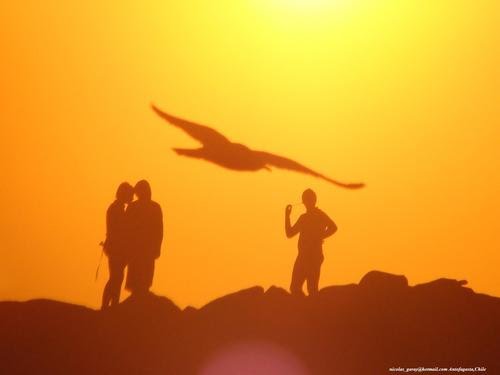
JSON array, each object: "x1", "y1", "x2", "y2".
[{"x1": 101, "y1": 182, "x2": 134, "y2": 310}]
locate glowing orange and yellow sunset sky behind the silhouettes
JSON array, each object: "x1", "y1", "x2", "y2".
[{"x1": 0, "y1": 0, "x2": 500, "y2": 307}]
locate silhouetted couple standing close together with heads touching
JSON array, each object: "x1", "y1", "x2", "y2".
[{"x1": 101, "y1": 180, "x2": 163, "y2": 309}]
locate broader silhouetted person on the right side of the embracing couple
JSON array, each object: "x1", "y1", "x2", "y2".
[{"x1": 126, "y1": 180, "x2": 163, "y2": 296}]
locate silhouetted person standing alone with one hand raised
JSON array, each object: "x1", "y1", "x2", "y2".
[{"x1": 285, "y1": 189, "x2": 337, "y2": 296}]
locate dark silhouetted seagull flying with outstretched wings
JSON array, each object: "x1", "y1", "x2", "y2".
[{"x1": 151, "y1": 105, "x2": 364, "y2": 189}]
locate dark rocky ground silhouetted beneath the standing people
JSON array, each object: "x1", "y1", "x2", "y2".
[{"x1": 0, "y1": 271, "x2": 500, "y2": 375}]
